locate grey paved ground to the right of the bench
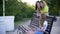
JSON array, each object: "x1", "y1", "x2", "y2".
[{"x1": 51, "y1": 17, "x2": 60, "y2": 34}]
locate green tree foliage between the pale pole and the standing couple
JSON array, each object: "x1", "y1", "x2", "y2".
[{"x1": 6, "y1": 0, "x2": 35, "y2": 21}]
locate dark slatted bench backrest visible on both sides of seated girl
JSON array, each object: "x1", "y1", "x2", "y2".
[{"x1": 30, "y1": 15, "x2": 55, "y2": 34}]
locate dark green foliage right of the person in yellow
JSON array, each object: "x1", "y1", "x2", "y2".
[{"x1": 45, "y1": 0, "x2": 60, "y2": 15}]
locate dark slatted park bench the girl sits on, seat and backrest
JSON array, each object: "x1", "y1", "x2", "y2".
[{"x1": 18, "y1": 15, "x2": 57, "y2": 34}]
